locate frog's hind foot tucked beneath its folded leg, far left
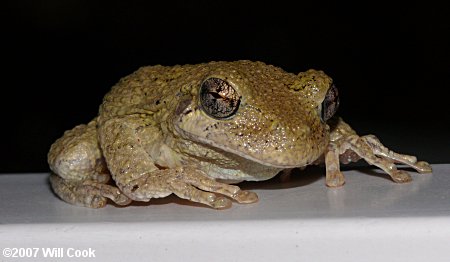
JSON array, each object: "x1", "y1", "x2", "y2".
[{"x1": 50, "y1": 174, "x2": 131, "y2": 208}]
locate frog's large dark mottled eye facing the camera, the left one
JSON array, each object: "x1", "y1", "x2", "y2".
[{"x1": 199, "y1": 77, "x2": 241, "y2": 119}]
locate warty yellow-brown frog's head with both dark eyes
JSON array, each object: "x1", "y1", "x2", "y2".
[{"x1": 174, "y1": 61, "x2": 339, "y2": 168}]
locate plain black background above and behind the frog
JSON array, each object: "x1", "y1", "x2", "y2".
[{"x1": 0, "y1": 0, "x2": 450, "y2": 172}]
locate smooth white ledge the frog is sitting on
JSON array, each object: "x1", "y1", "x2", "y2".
[{"x1": 0, "y1": 165, "x2": 450, "y2": 261}]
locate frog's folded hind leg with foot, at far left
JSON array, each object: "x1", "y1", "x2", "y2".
[{"x1": 48, "y1": 120, "x2": 131, "y2": 208}]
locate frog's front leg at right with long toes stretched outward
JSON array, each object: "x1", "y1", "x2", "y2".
[{"x1": 325, "y1": 118, "x2": 432, "y2": 187}]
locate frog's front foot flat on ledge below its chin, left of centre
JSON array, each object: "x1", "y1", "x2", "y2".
[{"x1": 123, "y1": 167, "x2": 258, "y2": 209}]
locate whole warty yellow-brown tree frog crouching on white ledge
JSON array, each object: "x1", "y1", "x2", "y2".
[{"x1": 48, "y1": 60, "x2": 432, "y2": 209}]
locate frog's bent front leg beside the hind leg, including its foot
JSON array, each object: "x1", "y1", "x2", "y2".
[{"x1": 100, "y1": 116, "x2": 258, "y2": 209}]
